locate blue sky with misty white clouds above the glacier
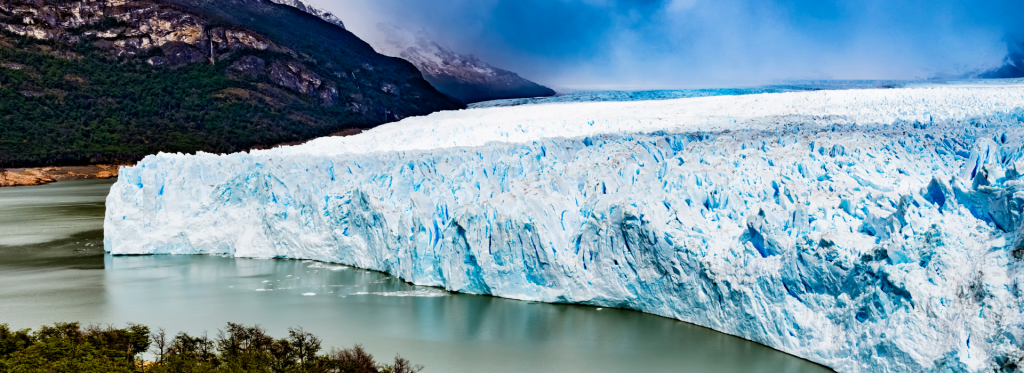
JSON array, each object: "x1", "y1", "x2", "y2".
[{"x1": 306, "y1": 0, "x2": 1024, "y2": 89}]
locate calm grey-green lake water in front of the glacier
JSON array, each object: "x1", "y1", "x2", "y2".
[{"x1": 0, "y1": 180, "x2": 830, "y2": 373}]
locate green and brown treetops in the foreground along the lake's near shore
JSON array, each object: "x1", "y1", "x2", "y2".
[{"x1": 0, "y1": 323, "x2": 423, "y2": 373}]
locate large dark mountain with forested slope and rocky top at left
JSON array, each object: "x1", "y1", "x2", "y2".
[{"x1": 0, "y1": 0, "x2": 464, "y2": 166}]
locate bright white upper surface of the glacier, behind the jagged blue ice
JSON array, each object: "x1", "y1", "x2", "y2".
[{"x1": 251, "y1": 80, "x2": 1024, "y2": 156}]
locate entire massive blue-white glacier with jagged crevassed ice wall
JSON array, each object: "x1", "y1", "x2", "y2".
[{"x1": 104, "y1": 84, "x2": 1024, "y2": 372}]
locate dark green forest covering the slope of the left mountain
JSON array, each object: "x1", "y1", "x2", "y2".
[{"x1": 0, "y1": 34, "x2": 364, "y2": 167}]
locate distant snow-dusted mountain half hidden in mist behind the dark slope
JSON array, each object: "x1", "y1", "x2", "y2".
[{"x1": 375, "y1": 25, "x2": 555, "y2": 103}]
